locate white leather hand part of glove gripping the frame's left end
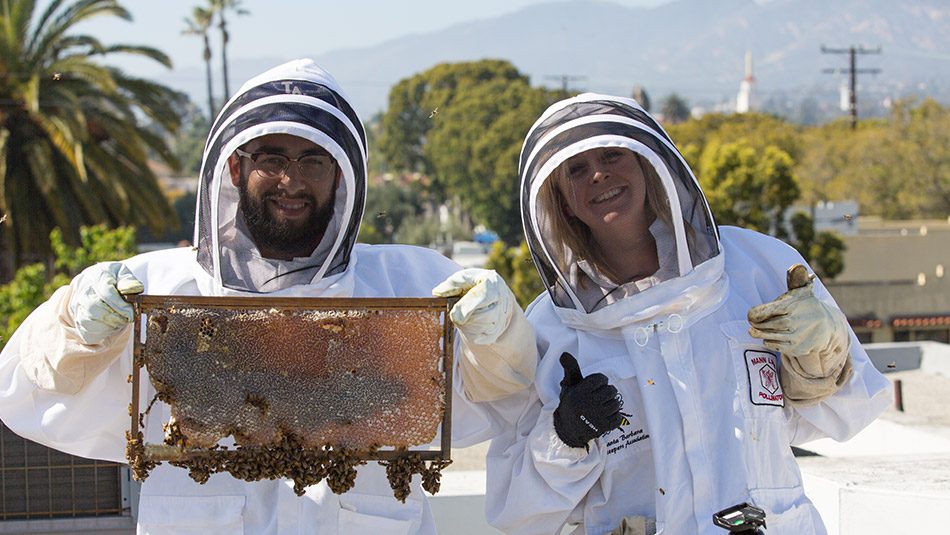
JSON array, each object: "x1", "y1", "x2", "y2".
[{"x1": 68, "y1": 262, "x2": 145, "y2": 345}]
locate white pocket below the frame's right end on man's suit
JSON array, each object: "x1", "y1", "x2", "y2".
[{"x1": 338, "y1": 494, "x2": 422, "y2": 535}]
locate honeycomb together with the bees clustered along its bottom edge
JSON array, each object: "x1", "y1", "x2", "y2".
[{"x1": 127, "y1": 296, "x2": 451, "y2": 500}]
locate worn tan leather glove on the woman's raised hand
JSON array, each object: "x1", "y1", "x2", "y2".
[{"x1": 748, "y1": 264, "x2": 851, "y2": 405}]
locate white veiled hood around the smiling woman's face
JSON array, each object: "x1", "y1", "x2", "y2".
[{"x1": 519, "y1": 93, "x2": 724, "y2": 329}]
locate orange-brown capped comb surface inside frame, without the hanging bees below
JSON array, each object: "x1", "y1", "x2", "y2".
[{"x1": 143, "y1": 307, "x2": 444, "y2": 449}]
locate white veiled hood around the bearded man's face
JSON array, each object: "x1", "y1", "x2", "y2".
[{"x1": 194, "y1": 59, "x2": 366, "y2": 293}]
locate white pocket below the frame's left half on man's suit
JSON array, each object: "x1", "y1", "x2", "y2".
[{"x1": 138, "y1": 495, "x2": 245, "y2": 535}]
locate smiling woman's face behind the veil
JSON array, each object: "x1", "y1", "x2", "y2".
[{"x1": 559, "y1": 147, "x2": 649, "y2": 241}]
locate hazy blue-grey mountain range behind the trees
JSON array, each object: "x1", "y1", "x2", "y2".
[{"x1": 167, "y1": 0, "x2": 950, "y2": 118}]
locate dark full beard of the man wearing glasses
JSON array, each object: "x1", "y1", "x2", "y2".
[{"x1": 238, "y1": 176, "x2": 336, "y2": 258}]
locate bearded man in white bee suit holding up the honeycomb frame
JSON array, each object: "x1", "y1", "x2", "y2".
[{"x1": 0, "y1": 60, "x2": 537, "y2": 534}]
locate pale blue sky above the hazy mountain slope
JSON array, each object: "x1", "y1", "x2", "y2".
[{"x1": 72, "y1": 0, "x2": 670, "y2": 77}]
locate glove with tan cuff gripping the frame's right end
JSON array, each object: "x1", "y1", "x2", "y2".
[{"x1": 432, "y1": 269, "x2": 538, "y2": 401}]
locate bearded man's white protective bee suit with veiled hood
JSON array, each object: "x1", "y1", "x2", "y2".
[{"x1": 0, "y1": 60, "x2": 506, "y2": 535}]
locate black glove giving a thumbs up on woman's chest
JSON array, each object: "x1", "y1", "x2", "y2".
[{"x1": 554, "y1": 353, "x2": 622, "y2": 448}]
